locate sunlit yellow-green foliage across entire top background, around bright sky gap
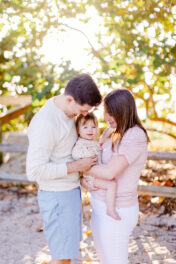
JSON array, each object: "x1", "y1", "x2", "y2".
[{"x1": 0, "y1": 0, "x2": 176, "y2": 140}]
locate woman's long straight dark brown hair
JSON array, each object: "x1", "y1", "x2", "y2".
[{"x1": 104, "y1": 88, "x2": 150, "y2": 146}]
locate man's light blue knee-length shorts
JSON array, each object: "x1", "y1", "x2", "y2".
[{"x1": 38, "y1": 187, "x2": 82, "y2": 259}]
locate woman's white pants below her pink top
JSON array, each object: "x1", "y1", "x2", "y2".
[{"x1": 92, "y1": 197, "x2": 139, "y2": 264}]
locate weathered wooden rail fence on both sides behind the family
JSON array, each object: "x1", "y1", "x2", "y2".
[{"x1": 0, "y1": 96, "x2": 176, "y2": 198}]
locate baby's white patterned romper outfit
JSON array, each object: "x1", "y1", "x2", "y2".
[{"x1": 72, "y1": 138, "x2": 101, "y2": 186}]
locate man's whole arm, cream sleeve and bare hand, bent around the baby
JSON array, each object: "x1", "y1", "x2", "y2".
[{"x1": 26, "y1": 120, "x2": 96, "y2": 181}]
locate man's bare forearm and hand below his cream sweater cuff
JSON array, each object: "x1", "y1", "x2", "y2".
[{"x1": 66, "y1": 156, "x2": 98, "y2": 174}]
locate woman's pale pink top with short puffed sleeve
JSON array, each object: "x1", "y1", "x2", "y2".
[{"x1": 92, "y1": 126, "x2": 147, "y2": 207}]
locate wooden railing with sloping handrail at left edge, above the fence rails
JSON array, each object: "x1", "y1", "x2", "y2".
[{"x1": 0, "y1": 95, "x2": 32, "y2": 164}]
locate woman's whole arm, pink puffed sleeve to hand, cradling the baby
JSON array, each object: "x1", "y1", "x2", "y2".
[{"x1": 86, "y1": 127, "x2": 147, "y2": 180}]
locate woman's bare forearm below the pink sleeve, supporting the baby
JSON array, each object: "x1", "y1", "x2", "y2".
[{"x1": 86, "y1": 154, "x2": 129, "y2": 180}]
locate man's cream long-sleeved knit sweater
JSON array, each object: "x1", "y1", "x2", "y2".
[{"x1": 26, "y1": 98, "x2": 79, "y2": 191}]
